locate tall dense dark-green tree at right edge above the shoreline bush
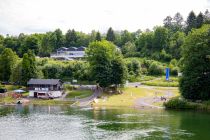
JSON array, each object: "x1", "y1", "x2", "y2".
[{"x1": 180, "y1": 25, "x2": 210, "y2": 100}]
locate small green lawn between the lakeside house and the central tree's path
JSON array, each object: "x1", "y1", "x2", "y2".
[{"x1": 66, "y1": 90, "x2": 93, "y2": 98}]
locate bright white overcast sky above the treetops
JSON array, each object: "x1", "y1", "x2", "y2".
[{"x1": 0, "y1": 0, "x2": 210, "y2": 35}]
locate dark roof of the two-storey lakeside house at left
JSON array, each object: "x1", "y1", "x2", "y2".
[{"x1": 27, "y1": 79, "x2": 60, "y2": 85}]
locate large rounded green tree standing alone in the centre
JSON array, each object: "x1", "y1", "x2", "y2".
[{"x1": 86, "y1": 40, "x2": 126, "y2": 87}]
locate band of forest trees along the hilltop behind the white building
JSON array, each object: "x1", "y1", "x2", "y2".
[{"x1": 0, "y1": 10, "x2": 207, "y2": 61}]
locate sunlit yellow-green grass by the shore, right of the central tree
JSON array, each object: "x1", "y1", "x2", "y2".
[{"x1": 93, "y1": 87, "x2": 179, "y2": 107}]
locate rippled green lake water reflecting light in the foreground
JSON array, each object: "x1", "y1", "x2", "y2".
[{"x1": 0, "y1": 105, "x2": 210, "y2": 140}]
